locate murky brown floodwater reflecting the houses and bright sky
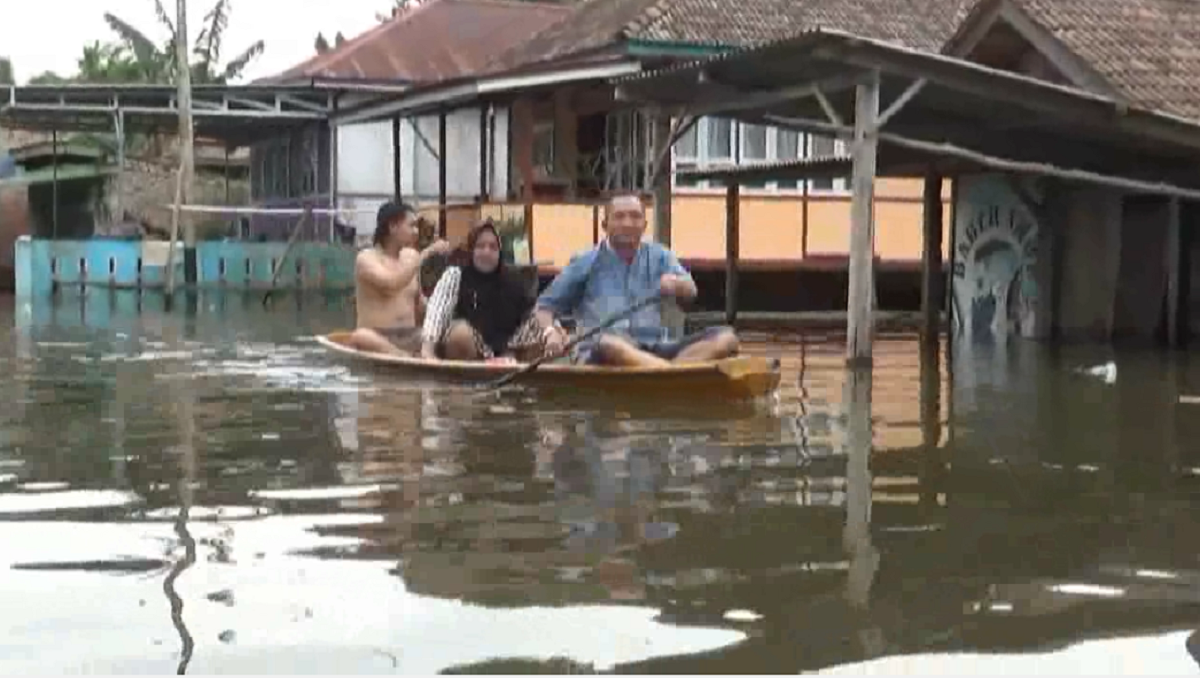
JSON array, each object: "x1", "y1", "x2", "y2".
[{"x1": 0, "y1": 293, "x2": 1200, "y2": 674}]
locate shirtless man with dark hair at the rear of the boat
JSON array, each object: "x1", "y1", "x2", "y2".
[{"x1": 349, "y1": 203, "x2": 450, "y2": 355}]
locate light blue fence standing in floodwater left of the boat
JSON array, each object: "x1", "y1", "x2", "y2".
[{"x1": 14, "y1": 236, "x2": 355, "y2": 296}]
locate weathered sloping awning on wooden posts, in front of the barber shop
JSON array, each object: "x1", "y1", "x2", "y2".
[{"x1": 612, "y1": 30, "x2": 1200, "y2": 187}]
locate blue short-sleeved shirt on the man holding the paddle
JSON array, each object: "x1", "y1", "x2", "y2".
[{"x1": 538, "y1": 241, "x2": 691, "y2": 344}]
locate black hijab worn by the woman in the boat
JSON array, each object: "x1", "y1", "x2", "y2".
[{"x1": 454, "y1": 220, "x2": 534, "y2": 355}]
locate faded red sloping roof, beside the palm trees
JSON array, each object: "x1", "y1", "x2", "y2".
[{"x1": 270, "y1": 0, "x2": 571, "y2": 83}]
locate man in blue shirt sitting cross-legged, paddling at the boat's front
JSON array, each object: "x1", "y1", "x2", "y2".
[{"x1": 538, "y1": 194, "x2": 738, "y2": 367}]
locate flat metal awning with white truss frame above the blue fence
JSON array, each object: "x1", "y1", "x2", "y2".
[{"x1": 0, "y1": 84, "x2": 340, "y2": 144}]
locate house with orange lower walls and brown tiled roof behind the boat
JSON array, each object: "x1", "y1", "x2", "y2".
[{"x1": 290, "y1": 0, "x2": 967, "y2": 289}]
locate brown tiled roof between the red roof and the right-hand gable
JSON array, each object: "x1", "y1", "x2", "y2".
[{"x1": 493, "y1": 0, "x2": 973, "y2": 68}]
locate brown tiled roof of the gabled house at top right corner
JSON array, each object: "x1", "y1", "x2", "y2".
[{"x1": 1015, "y1": 0, "x2": 1200, "y2": 119}]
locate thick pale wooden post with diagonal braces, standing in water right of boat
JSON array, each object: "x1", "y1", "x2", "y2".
[{"x1": 846, "y1": 72, "x2": 880, "y2": 365}]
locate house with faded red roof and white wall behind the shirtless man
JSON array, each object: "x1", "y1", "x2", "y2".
[{"x1": 251, "y1": 0, "x2": 571, "y2": 242}]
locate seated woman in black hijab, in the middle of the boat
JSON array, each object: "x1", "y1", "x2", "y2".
[{"x1": 421, "y1": 220, "x2": 544, "y2": 362}]
